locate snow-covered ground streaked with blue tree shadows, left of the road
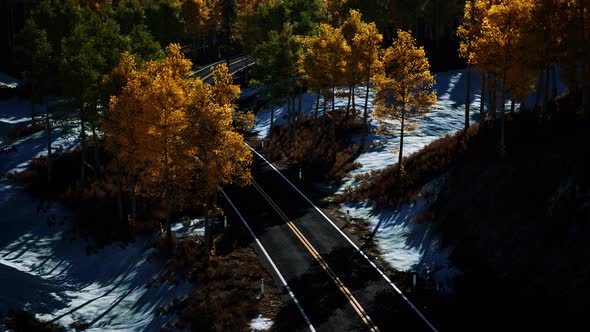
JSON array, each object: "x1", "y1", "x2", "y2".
[{"x1": 0, "y1": 75, "x2": 202, "y2": 331}]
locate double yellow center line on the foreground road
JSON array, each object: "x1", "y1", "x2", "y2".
[{"x1": 251, "y1": 179, "x2": 379, "y2": 332}]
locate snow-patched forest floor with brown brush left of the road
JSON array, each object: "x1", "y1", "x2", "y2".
[{"x1": 0, "y1": 76, "x2": 280, "y2": 331}]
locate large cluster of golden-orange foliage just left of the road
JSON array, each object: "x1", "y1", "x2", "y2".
[{"x1": 103, "y1": 44, "x2": 251, "y2": 208}]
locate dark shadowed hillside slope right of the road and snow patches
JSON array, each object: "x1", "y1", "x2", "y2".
[{"x1": 431, "y1": 102, "x2": 590, "y2": 331}]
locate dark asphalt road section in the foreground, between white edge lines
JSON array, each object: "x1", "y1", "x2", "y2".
[{"x1": 225, "y1": 156, "x2": 432, "y2": 331}]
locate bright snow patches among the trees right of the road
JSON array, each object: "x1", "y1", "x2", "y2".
[{"x1": 254, "y1": 70, "x2": 565, "y2": 291}]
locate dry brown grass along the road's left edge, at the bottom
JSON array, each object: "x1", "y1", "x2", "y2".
[{"x1": 157, "y1": 237, "x2": 281, "y2": 331}]
